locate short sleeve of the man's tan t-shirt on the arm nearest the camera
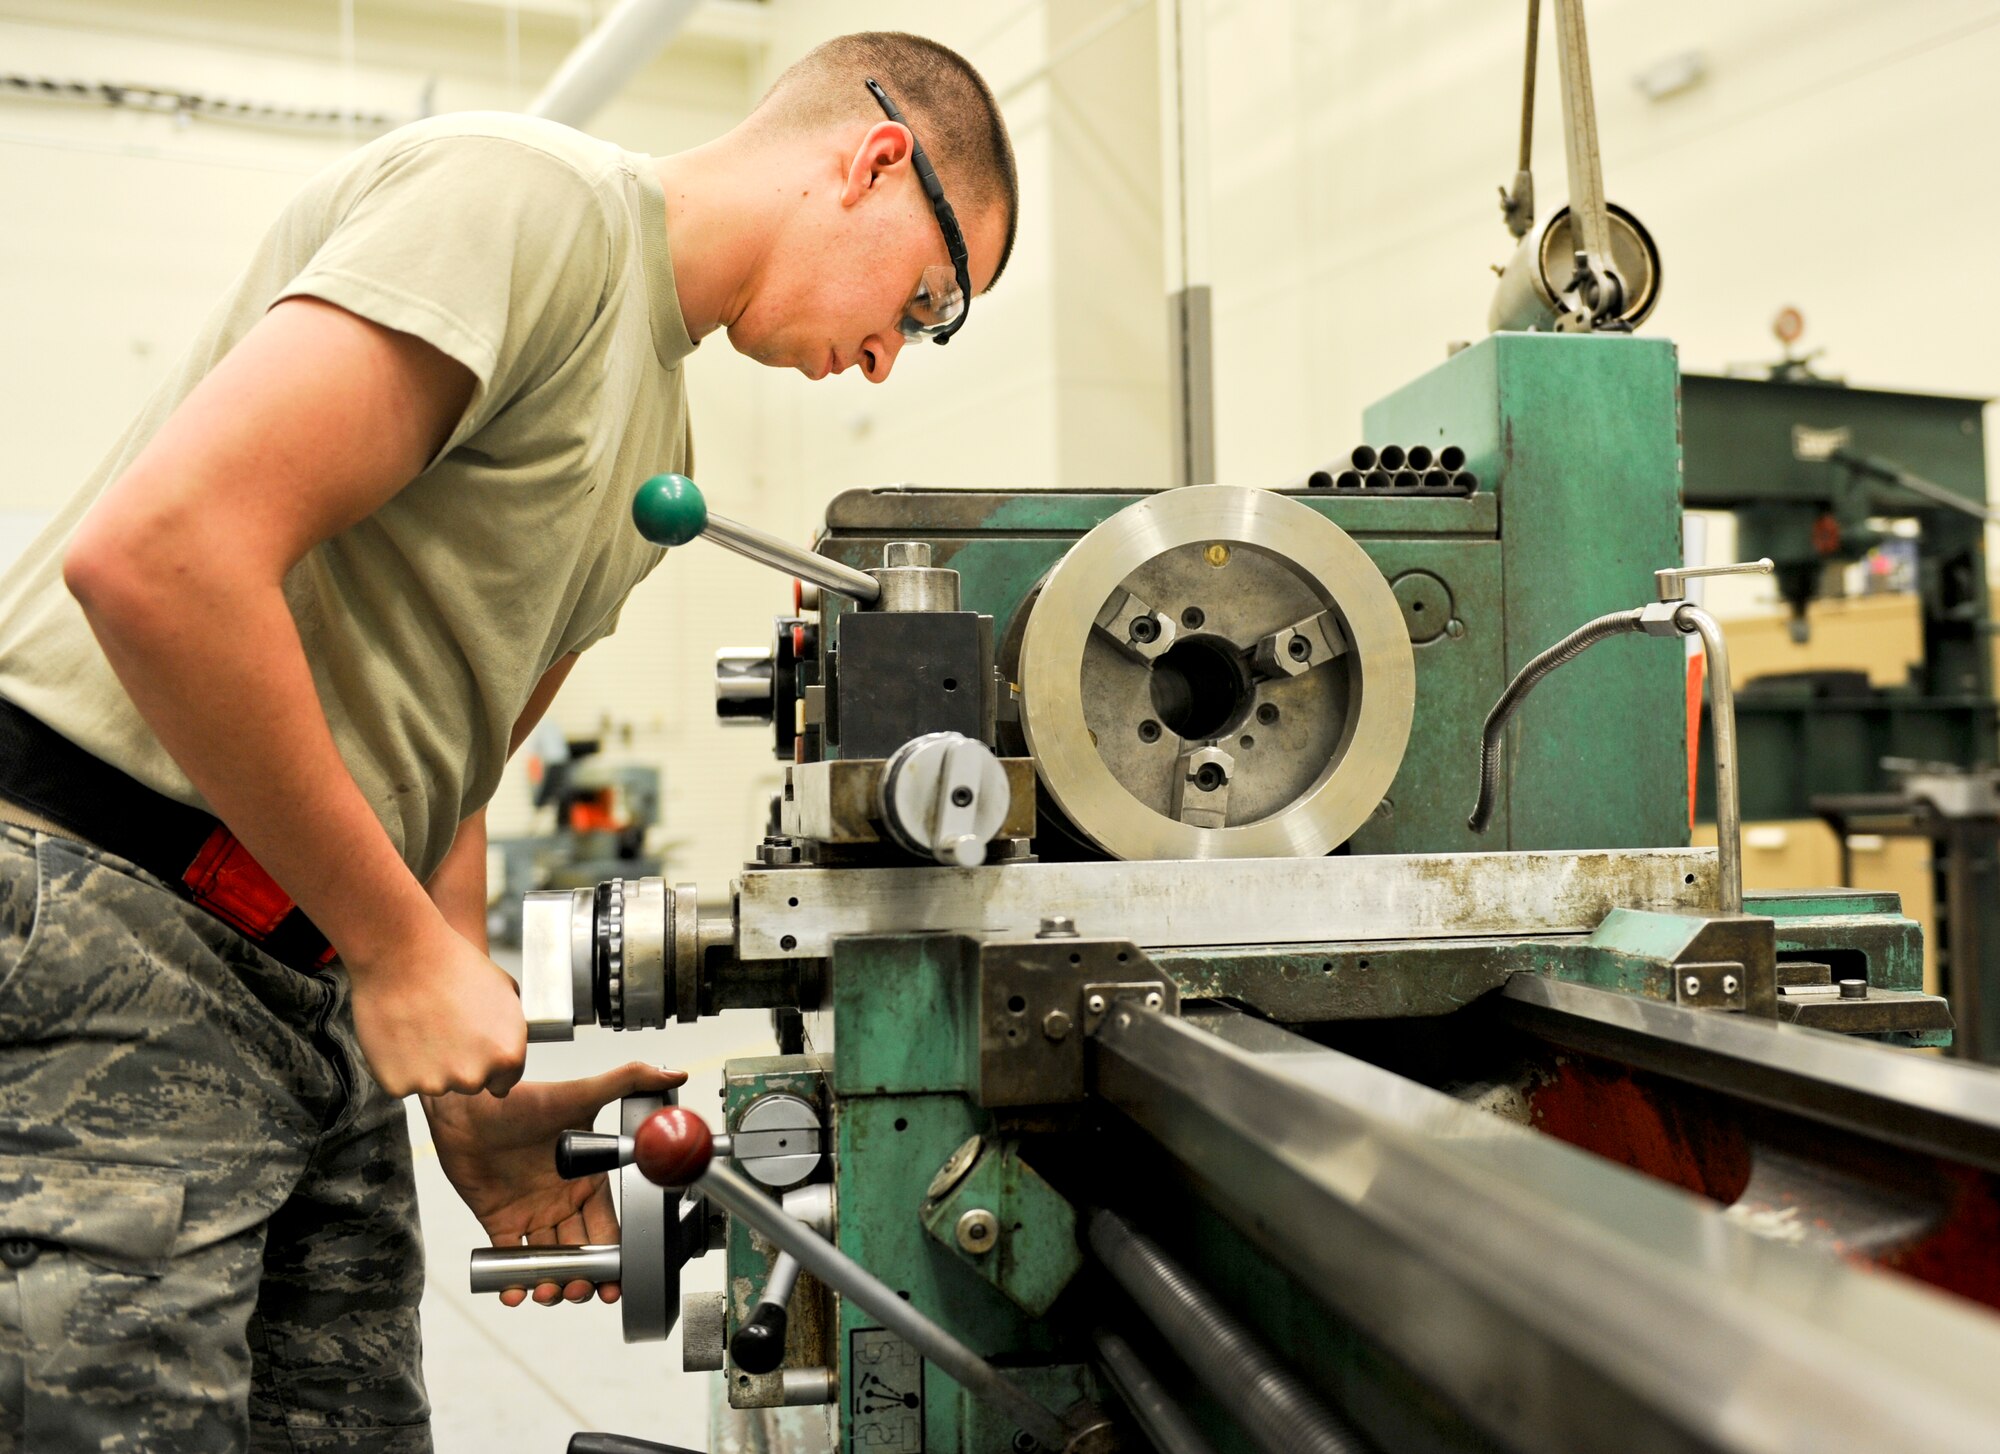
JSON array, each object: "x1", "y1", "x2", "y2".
[{"x1": 272, "y1": 136, "x2": 610, "y2": 448}]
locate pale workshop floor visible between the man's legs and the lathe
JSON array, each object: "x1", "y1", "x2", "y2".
[{"x1": 410, "y1": 952, "x2": 774, "y2": 1454}]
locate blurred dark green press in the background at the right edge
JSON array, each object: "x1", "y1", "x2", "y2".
[{"x1": 1682, "y1": 364, "x2": 2000, "y2": 1058}]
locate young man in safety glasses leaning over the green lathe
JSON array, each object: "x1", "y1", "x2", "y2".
[{"x1": 0, "y1": 34, "x2": 1016, "y2": 1454}]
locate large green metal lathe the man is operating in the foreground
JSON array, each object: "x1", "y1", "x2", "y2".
[{"x1": 474, "y1": 334, "x2": 2000, "y2": 1454}]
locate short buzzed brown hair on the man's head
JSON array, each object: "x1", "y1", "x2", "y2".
[{"x1": 754, "y1": 30, "x2": 1020, "y2": 286}]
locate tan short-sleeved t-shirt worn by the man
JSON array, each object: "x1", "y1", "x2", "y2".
[{"x1": 0, "y1": 114, "x2": 694, "y2": 878}]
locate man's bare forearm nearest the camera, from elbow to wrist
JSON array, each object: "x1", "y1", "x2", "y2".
[{"x1": 70, "y1": 544, "x2": 436, "y2": 968}]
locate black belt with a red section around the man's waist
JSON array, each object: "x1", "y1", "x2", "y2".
[{"x1": 0, "y1": 698, "x2": 332, "y2": 972}]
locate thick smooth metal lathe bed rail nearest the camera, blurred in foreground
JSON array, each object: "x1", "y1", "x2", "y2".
[{"x1": 1096, "y1": 1006, "x2": 2000, "y2": 1454}]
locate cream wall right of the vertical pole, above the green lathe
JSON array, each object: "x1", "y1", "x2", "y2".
[{"x1": 1208, "y1": 0, "x2": 2000, "y2": 604}]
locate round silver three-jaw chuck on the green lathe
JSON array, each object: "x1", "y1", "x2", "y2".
[{"x1": 1020, "y1": 484, "x2": 1416, "y2": 858}]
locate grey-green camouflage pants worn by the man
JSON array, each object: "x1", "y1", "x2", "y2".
[{"x1": 0, "y1": 826, "x2": 430, "y2": 1454}]
